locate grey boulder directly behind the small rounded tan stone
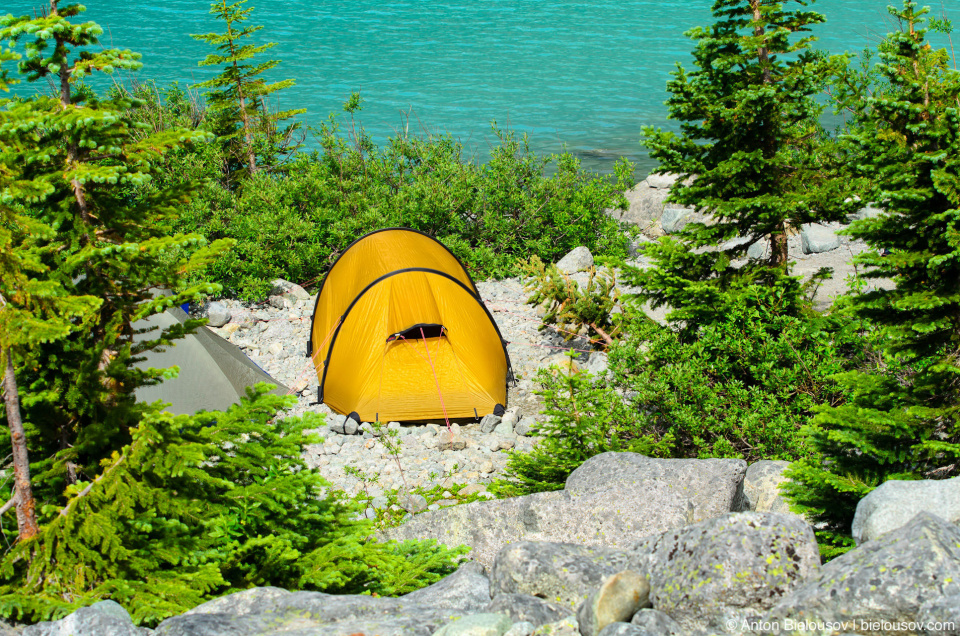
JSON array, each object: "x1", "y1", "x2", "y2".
[{"x1": 490, "y1": 541, "x2": 634, "y2": 614}]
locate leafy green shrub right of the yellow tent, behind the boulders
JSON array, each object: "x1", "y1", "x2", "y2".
[{"x1": 497, "y1": 285, "x2": 863, "y2": 495}]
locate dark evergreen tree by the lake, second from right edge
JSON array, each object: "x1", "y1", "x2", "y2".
[{"x1": 633, "y1": 0, "x2": 844, "y2": 324}]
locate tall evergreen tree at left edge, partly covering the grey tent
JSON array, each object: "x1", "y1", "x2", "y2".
[{"x1": 0, "y1": 0, "x2": 227, "y2": 500}]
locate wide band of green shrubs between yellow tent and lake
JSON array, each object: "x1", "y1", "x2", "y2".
[{"x1": 154, "y1": 96, "x2": 632, "y2": 299}]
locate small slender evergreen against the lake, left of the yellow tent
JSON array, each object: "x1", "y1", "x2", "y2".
[{"x1": 192, "y1": 0, "x2": 306, "y2": 181}]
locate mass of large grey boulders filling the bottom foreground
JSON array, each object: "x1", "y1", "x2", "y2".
[{"x1": 22, "y1": 453, "x2": 960, "y2": 636}]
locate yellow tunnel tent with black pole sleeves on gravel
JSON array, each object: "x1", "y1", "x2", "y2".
[{"x1": 307, "y1": 228, "x2": 511, "y2": 422}]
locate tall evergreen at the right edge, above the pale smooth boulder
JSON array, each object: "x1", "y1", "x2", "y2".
[{"x1": 789, "y1": 0, "x2": 960, "y2": 557}]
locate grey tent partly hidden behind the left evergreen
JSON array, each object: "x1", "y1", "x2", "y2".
[{"x1": 134, "y1": 304, "x2": 288, "y2": 415}]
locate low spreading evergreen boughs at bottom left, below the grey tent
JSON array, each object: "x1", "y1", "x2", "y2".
[{"x1": 0, "y1": 385, "x2": 460, "y2": 625}]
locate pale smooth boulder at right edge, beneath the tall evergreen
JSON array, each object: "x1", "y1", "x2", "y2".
[{"x1": 852, "y1": 477, "x2": 960, "y2": 545}]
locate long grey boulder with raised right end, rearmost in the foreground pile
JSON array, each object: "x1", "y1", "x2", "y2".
[{"x1": 385, "y1": 453, "x2": 747, "y2": 566}]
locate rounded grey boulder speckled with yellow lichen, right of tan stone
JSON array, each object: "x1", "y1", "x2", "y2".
[{"x1": 635, "y1": 512, "x2": 820, "y2": 633}]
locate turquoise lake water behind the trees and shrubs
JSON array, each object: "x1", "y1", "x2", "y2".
[{"x1": 0, "y1": 0, "x2": 960, "y2": 174}]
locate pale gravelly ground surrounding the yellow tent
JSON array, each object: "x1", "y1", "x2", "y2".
[{"x1": 207, "y1": 279, "x2": 605, "y2": 507}]
